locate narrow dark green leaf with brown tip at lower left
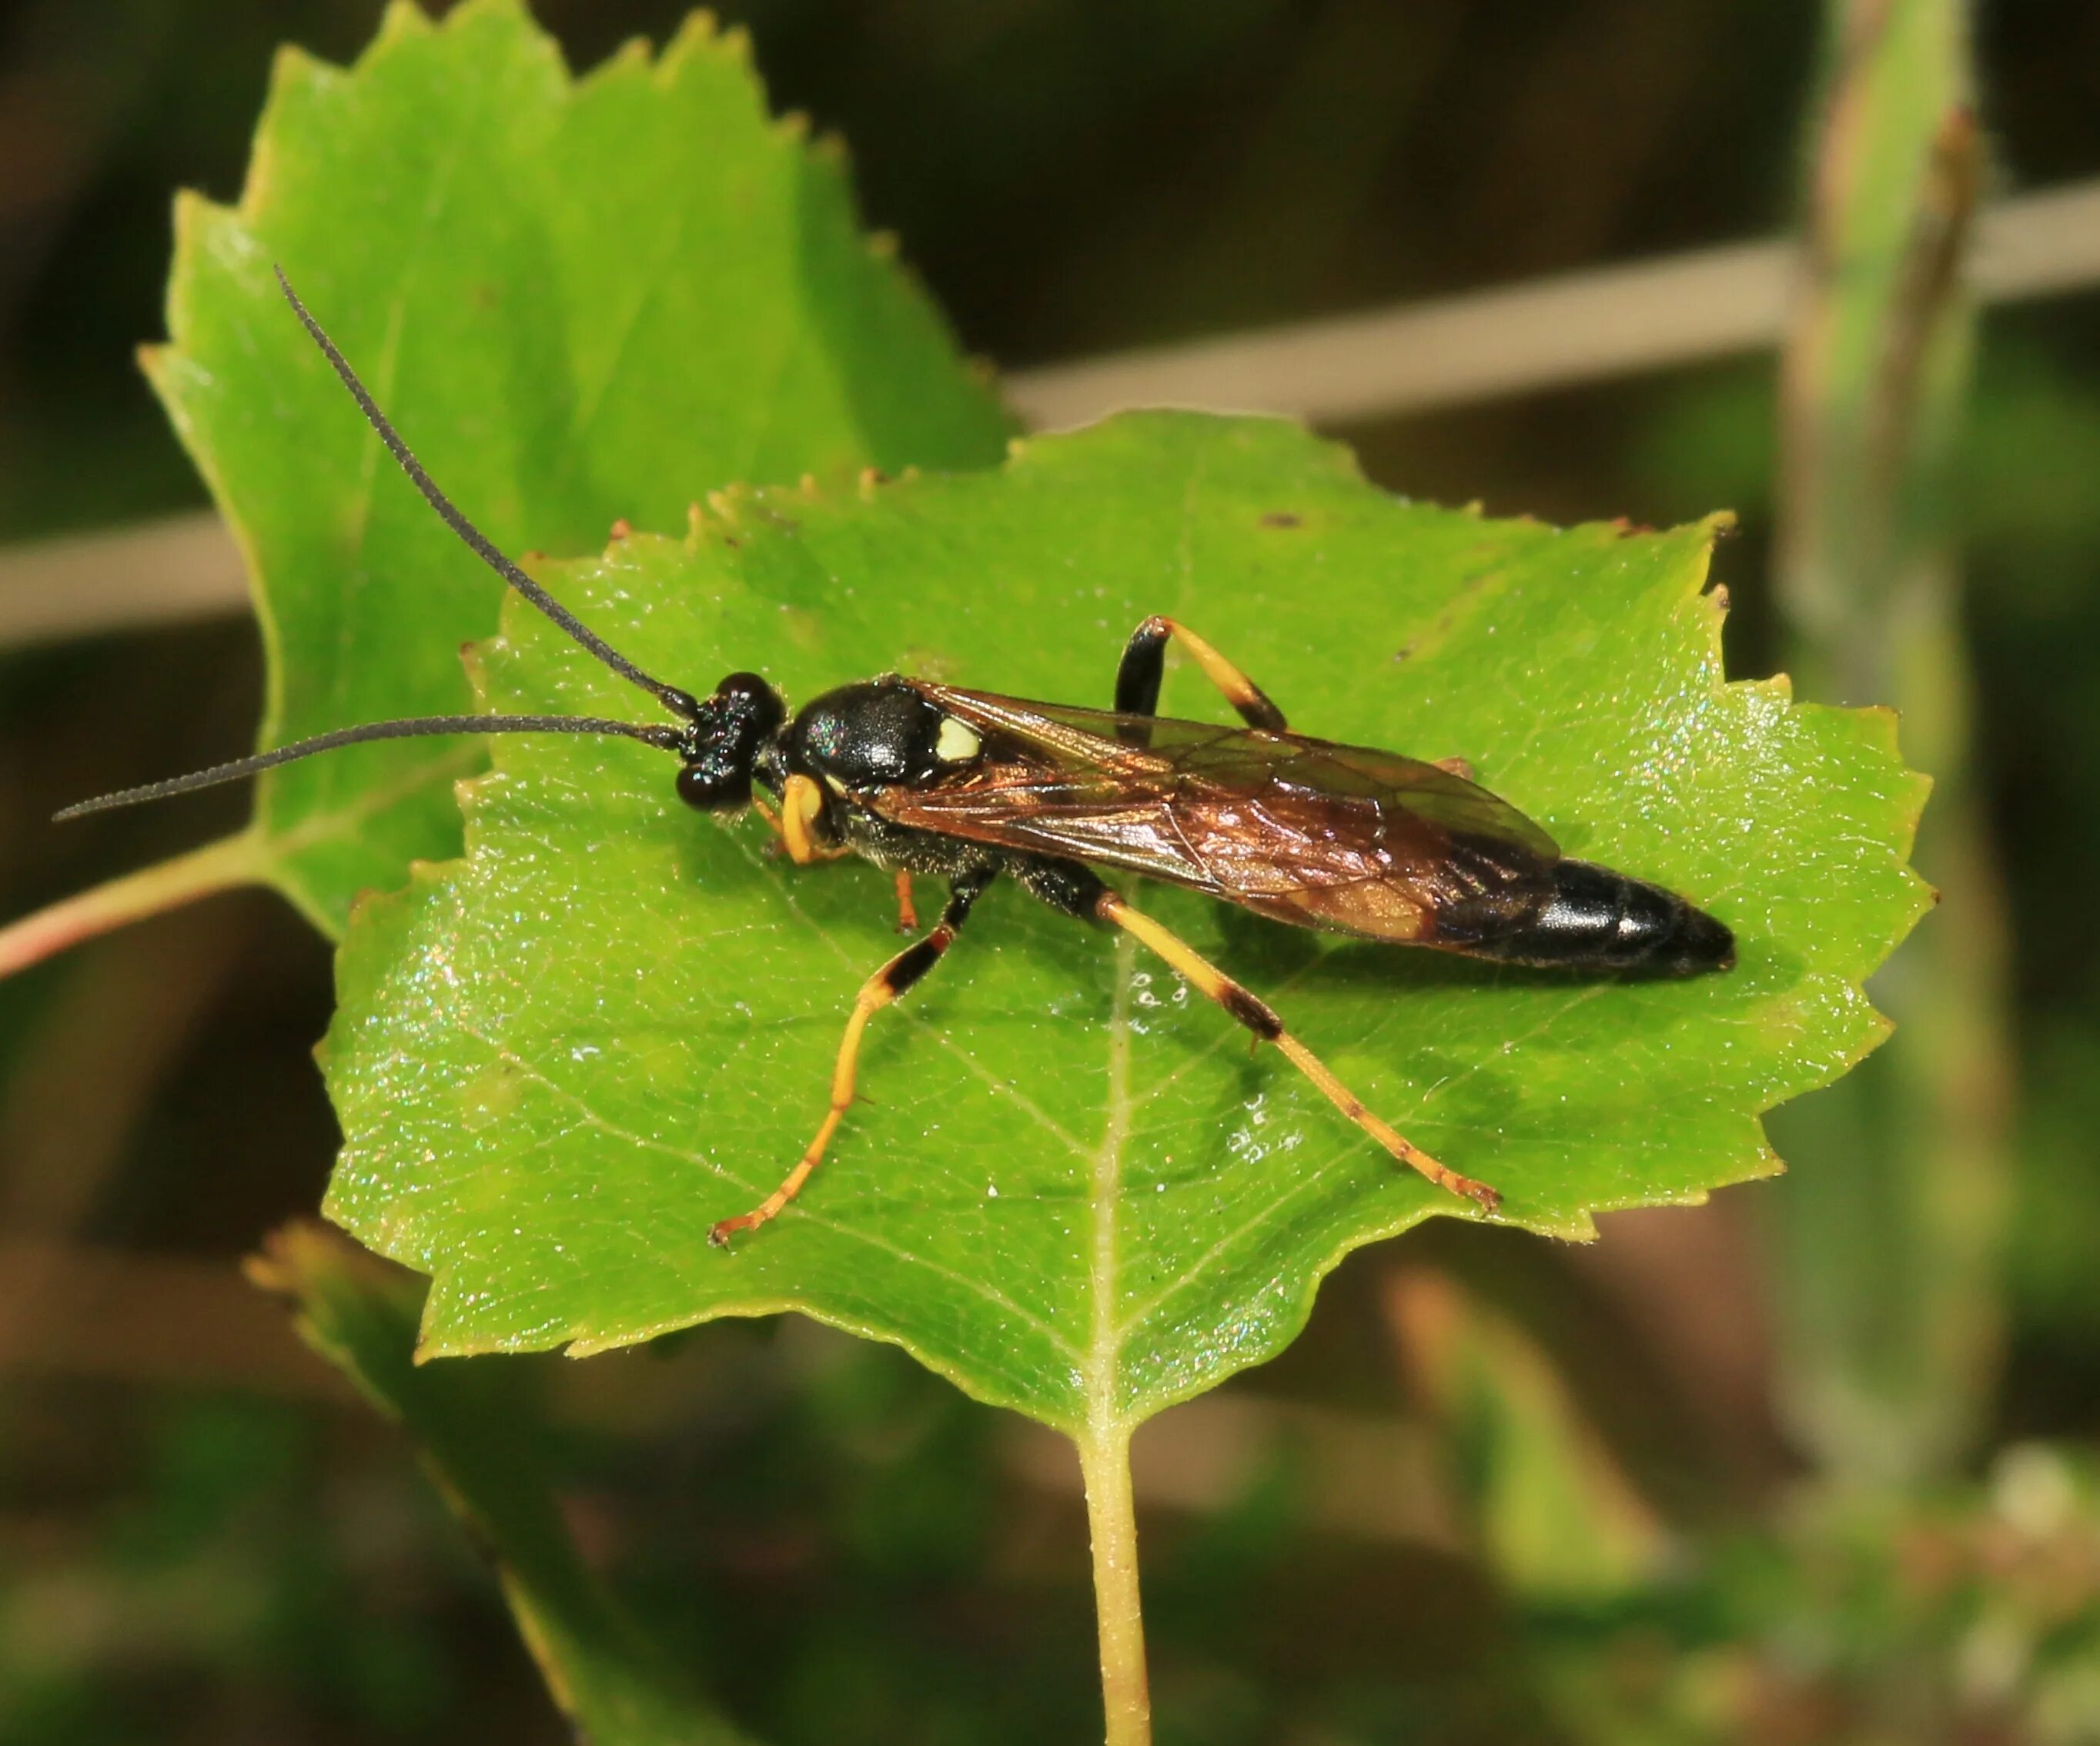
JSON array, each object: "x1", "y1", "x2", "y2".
[{"x1": 248, "y1": 1223, "x2": 745, "y2": 1746}]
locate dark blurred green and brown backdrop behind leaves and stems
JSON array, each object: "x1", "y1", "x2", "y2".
[{"x1": 0, "y1": 0, "x2": 2100, "y2": 1746}]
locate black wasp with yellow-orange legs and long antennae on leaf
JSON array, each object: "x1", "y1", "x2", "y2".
[{"x1": 59, "y1": 271, "x2": 1734, "y2": 1244}]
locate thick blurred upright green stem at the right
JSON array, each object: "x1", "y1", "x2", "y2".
[{"x1": 1772, "y1": 0, "x2": 2010, "y2": 1483}]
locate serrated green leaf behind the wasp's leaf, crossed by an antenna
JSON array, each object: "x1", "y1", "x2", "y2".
[{"x1": 147, "y1": 0, "x2": 1006, "y2": 933}]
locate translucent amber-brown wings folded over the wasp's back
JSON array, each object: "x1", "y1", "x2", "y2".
[{"x1": 874, "y1": 681, "x2": 1560, "y2": 945}]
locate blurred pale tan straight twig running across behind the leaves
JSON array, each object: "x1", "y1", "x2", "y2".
[{"x1": 0, "y1": 181, "x2": 2100, "y2": 649}]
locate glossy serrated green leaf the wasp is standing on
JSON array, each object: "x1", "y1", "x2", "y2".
[{"x1": 328, "y1": 414, "x2": 1924, "y2": 1429}]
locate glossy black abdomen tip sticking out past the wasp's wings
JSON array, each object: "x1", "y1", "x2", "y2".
[{"x1": 1463, "y1": 861, "x2": 1734, "y2": 977}]
